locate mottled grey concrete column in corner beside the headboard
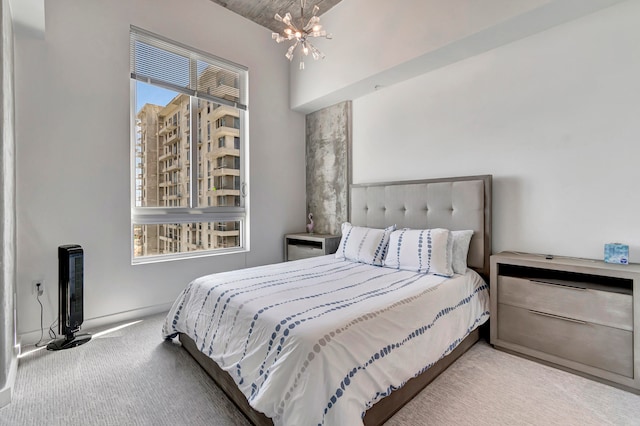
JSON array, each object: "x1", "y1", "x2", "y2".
[{"x1": 306, "y1": 101, "x2": 352, "y2": 235}]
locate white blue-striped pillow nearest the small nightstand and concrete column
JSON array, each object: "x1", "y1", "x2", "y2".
[{"x1": 336, "y1": 222, "x2": 396, "y2": 266}]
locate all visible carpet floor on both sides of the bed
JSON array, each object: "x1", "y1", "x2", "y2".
[{"x1": 0, "y1": 316, "x2": 640, "y2": 426}]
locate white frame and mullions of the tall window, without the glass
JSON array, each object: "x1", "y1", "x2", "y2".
[{"x1": 130, "y1": 25, "x2": 249, "y2": 265}]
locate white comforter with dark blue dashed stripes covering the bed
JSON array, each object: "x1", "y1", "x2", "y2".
[{"x1": 163, "y1": 256, "x2": 489, "y2": 426}]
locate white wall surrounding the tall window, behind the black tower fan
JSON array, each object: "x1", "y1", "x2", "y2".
[{"x1": 16, "y1": 0, "x2": 305, "y2": 341}]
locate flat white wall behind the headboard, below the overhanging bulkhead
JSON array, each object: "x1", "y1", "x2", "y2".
[{"x1": 344, "y1": 1, "x2": 640, "y2": 262}]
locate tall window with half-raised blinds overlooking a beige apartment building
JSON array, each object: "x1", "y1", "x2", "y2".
[{"x1": 130, "y1": 27, "x2": 248, "y2": 263}]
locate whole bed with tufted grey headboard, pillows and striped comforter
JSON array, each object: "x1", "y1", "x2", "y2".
[{"x1": 163, "y1": 175, "x2": 492, "y2": 425}]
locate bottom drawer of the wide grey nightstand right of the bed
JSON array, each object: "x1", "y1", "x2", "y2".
[{"x1": 498, "y1": 304, "x2": 633, "y2": 378}]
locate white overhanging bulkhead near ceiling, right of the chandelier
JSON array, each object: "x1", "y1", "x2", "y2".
[{"x1": 291, "y1": 0, "x2": 622, "y2": 113}]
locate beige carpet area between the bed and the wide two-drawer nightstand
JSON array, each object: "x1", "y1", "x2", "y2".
[{"x1": 387, "y1": 341, "x2": 640, "y2": 426}]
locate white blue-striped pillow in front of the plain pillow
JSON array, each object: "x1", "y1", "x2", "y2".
[{"x1": 384, "y1": 228, "x2": 453, "y2": 277}]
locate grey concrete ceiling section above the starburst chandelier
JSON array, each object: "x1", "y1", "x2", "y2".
[{"x1": 211, "y1": 0, "x2": 341, "y2": 32}]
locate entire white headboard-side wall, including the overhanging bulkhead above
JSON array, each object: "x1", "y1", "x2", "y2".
[{"x1": 291, "y1": 0, "x2": 640, "y2": 262}]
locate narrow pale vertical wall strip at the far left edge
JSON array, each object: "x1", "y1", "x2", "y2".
[{"x1": 0, "y1": 0, "x2": 18, "y2": 408}]
